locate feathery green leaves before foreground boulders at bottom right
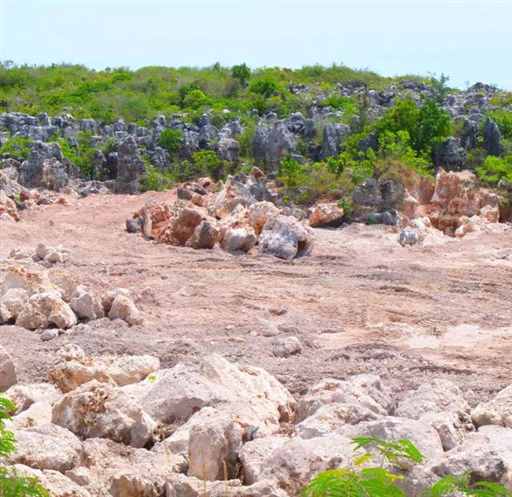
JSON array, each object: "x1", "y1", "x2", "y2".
[{"x1": 303, "y1": 437, "x2": 512, "y2": 497}]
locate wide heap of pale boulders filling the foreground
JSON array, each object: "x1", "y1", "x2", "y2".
[{"x1": 0, "y1": 344, "x2": 512, "y2": 497}]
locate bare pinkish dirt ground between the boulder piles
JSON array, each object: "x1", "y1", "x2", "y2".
[{"x1": 0, "y1": 193, "x2": 512, "y2": 401}]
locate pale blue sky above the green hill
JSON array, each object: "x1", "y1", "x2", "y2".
[{"x1": 0, "y1": 0, "x2": 512, "y2": 89}]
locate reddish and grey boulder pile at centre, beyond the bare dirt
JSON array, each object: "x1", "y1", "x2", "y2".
[{"x1": 127, "y1": 168, "x2": 313, "y2": 260}]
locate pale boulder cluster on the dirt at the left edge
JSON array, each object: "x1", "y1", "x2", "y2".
[{"x1": 0, "y1": 264, "x2": 142, "y2": 331}]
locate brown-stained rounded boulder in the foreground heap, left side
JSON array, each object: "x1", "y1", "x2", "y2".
[{"x1": 52, "y1": 380, "x2": 155, "y2": 447}]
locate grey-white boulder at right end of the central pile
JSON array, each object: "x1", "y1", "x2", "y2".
[{"x1": 259, "y1": 215, "x2": 313, "y2": 260}]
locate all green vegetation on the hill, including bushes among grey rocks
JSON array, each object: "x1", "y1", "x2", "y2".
[{"x1": 0, "y1": 63, "x2": 512, "y2": 200}]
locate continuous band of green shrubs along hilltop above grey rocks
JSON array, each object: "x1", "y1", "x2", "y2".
[{"x1": 0, "y1": 63, "x2": 421, "y2": 123}]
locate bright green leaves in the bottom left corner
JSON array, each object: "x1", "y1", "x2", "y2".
[{"x1": 0, "y1": 396, "x2": 48, "y2": 497}]
